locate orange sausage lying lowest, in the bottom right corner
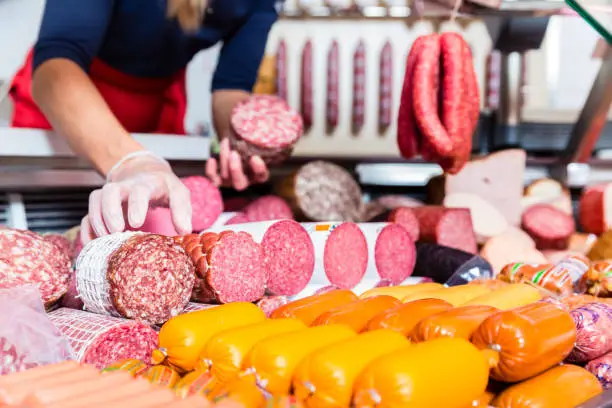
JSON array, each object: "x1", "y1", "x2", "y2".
[{"x1": 493, "y1": 364, "x2": 602, "y2": 408}]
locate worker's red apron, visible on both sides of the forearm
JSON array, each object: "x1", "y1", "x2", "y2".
[{"x1": 9, "y1": 51, "x2": 187, "y2": 135}]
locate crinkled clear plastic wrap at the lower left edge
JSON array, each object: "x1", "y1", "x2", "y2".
[{"x1": 0, "y1": 285, "x2": 73, "y2": 375}]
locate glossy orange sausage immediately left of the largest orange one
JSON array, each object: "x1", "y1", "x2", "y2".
[{"x1": 410, "y1": 306, "x2": 498, "y2": 342}]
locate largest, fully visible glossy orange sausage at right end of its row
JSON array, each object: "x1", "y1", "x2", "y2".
[{"x1": 472, "y1": 302, "x2": 576, "y2": 382}]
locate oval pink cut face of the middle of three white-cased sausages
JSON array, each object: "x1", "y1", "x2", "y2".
[{"x1": 323, "y1": 222, "x2": 368, "y2": 289}]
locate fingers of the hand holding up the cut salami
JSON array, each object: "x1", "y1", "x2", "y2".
[{"x1": 206, "y1": 138, "x2": 270, "y2": 191}]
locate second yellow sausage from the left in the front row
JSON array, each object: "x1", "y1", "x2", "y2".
[{"x1": 197, "y1": 319, "x2": 306, "y2": 382}]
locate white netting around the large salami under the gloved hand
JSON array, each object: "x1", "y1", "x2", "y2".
[{"x1": 75, "y1": 232, "x2": 138, "y2": 317}]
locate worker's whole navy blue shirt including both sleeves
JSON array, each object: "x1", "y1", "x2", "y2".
[{"x1": 33, "y1": 0, "x2": 277, "y2": 91}]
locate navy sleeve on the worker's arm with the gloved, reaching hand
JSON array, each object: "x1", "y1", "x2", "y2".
[{"x1": 32, "y1": 0, "x2": 115, "y2": 71}]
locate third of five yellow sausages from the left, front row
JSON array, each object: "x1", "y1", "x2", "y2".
[{"x1": 243, "y1": 324, "x2": 356, "y2": 395}]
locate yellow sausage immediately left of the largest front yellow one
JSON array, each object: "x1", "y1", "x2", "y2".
[{"x1": 293, "y1": 329, "x2": 409, "y2": 408}]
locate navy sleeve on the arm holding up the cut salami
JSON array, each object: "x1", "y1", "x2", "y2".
[{"x1": 212, "y1": 0, "x2": 278, "y2": 92}]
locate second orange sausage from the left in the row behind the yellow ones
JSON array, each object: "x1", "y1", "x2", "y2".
[{"x1": 312, "y1": 295, "x2": 402, "y2": 333}]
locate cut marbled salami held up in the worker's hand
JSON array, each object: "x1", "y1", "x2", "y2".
[{"x1": 230, "y1": 95, "x2": 304, "y2": 164}]
